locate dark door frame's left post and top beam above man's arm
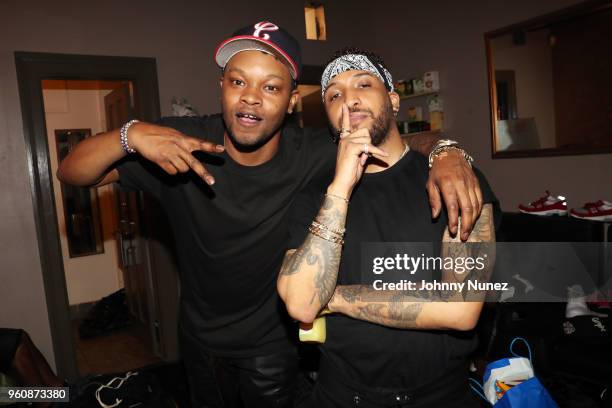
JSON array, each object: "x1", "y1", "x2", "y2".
[{"x1": 15, "y1": 51, "x2": 160, "y2": 379}]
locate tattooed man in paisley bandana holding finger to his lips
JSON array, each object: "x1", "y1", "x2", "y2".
[{"x1": 277, "y1": 50, "x2": 499, "y2": 408}]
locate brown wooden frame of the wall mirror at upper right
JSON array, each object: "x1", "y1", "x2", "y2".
[{"x1": 484, "y1": 0, "x2": 612, "y2": 159}]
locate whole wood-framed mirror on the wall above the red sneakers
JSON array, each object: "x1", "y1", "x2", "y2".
[{"x1": 485, "y1": 1, "x2": 612, "y2": 158}]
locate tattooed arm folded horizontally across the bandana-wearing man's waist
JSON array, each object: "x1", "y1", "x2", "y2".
[{"x1": 328, "y1": 204, "x2": 495, "y2": 330}]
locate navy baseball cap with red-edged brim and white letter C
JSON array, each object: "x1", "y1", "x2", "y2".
[{"x1": 215, "y1": 21, "x2": 302, "y2": 81}]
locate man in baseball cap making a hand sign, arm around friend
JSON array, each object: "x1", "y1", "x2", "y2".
[{"x1": 58, "y1": 21, "x2": 482, "y2": 407}]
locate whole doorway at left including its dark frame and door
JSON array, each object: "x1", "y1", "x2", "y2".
[{"x1": 15, "y1": 52, "x2": 178, "y2": 379}]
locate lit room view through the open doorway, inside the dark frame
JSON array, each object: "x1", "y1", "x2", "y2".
[{"x1": 42, "y1": 79, "x2": 159, "y2": 376}]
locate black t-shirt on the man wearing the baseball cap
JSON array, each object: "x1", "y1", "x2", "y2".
[{"x1": 118, "y1": 115, "x2": 335, "y2": 356}]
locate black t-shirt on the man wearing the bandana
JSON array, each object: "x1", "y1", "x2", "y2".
[{"x1": 289, "y1": 152, "x2": 497, "y2": 389}]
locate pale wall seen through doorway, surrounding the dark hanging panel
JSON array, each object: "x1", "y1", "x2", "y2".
[{"x1": 43, "y1": 89, "x2": 123, "y2": 305}]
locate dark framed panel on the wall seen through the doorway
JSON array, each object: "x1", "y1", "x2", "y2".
[{"x1": 55, "y1": 129, "x2": 104, "y2": 258}]
